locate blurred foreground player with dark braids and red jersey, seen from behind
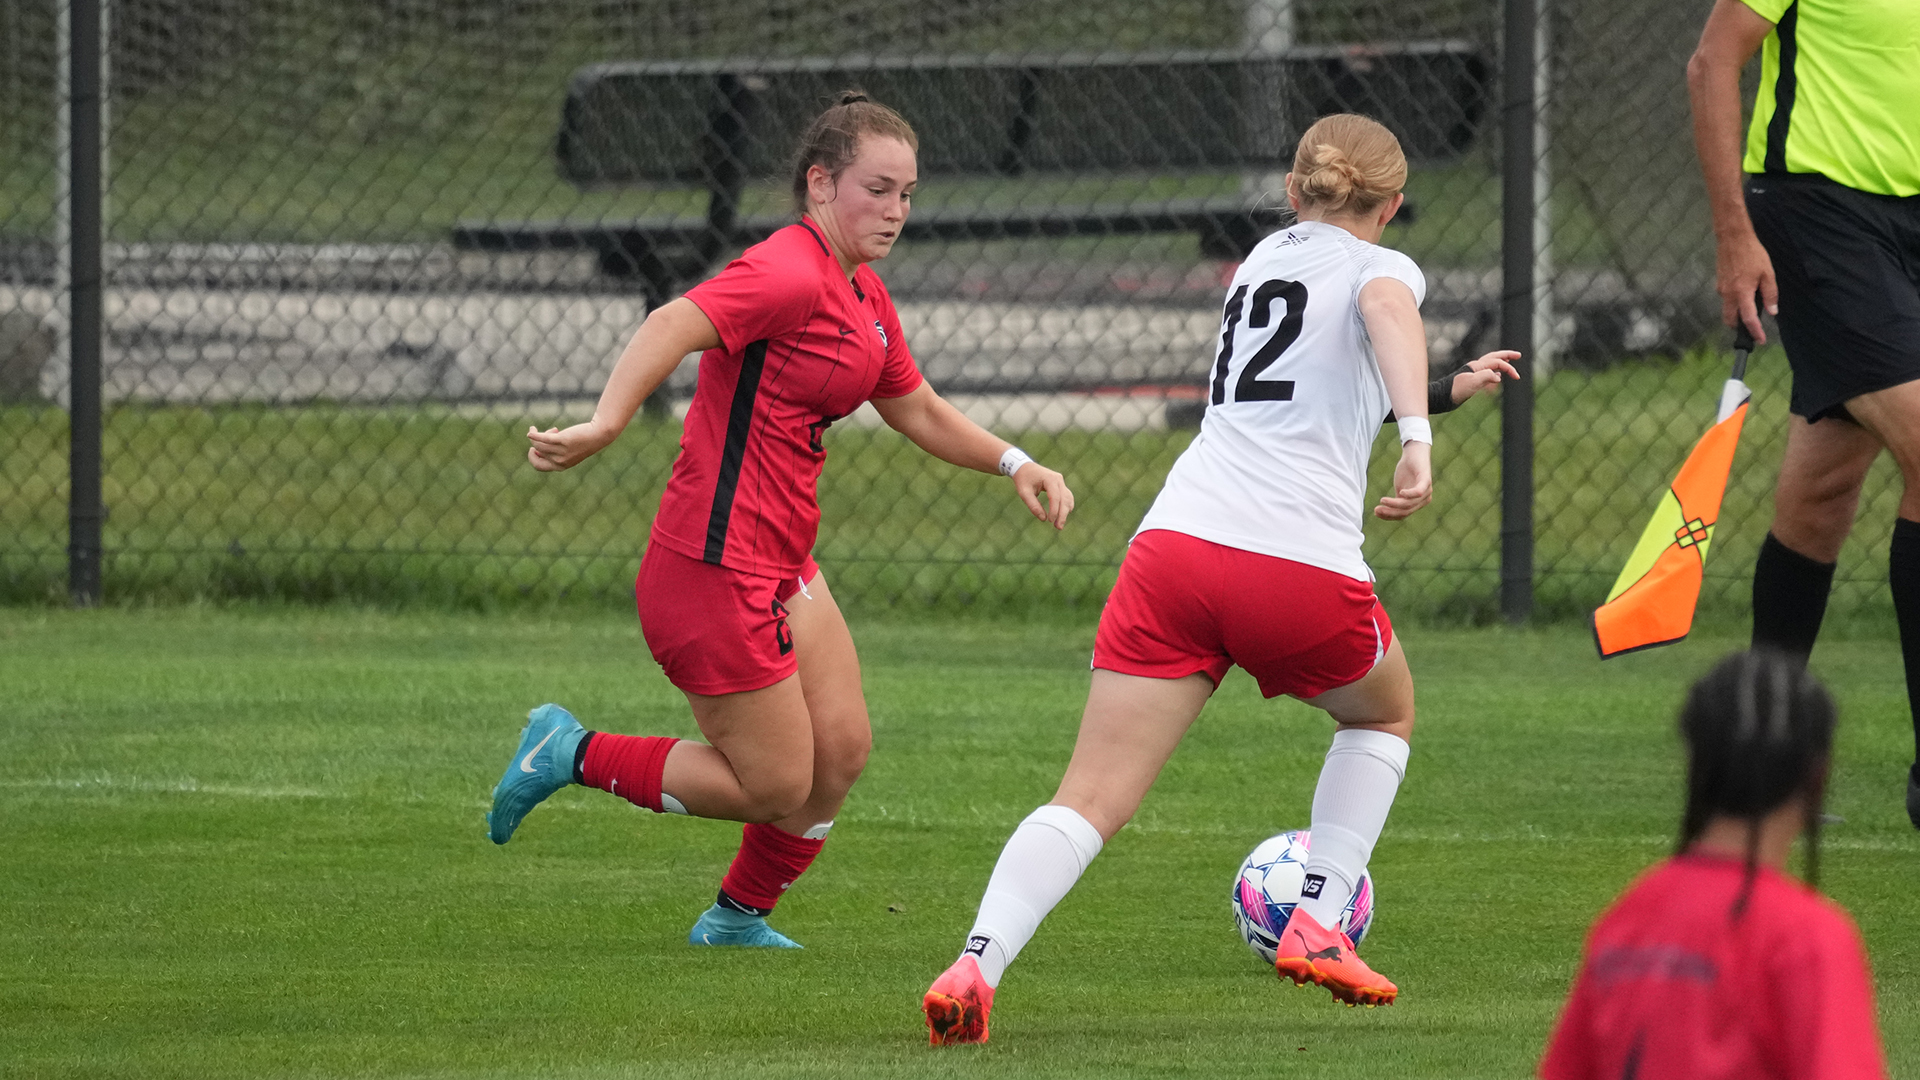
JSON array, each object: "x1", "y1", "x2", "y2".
[{"x1": 1540, "y1": 650, "x2": 1887, "y2": 1080}]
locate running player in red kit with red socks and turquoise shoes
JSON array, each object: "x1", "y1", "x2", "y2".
[{"x1": 488, "y1": 92, "x2": 1073, "y2": 947}]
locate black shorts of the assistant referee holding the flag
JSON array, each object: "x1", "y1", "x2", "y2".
[{"x1": 1747, "y1": 173, "x2": 1920, "y2": 421}]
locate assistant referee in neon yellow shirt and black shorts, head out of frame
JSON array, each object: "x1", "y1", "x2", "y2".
[{"x1": 1688, "y1": 0, "x2": 1920, "y2": 828}]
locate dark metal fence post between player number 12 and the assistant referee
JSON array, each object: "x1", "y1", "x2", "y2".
[{"x1": 1500, "y1": 0, "x2": 1538, "y2": 623}]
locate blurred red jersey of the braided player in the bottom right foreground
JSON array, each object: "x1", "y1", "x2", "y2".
[{"x1": 1540, "y1": 855, "x2": 1887, "y2": 1080}]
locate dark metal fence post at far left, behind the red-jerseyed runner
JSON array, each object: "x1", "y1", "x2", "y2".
[{"x1": 67, "y1": 0, "x2": 106, "y2": 607}]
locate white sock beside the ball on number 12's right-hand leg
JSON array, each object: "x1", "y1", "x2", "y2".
[{"x1": 1300, "y1": 728, "x2": 1409, "y2": 928}]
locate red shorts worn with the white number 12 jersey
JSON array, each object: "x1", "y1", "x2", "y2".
[{"x1": 1092, "y1": 528, "x2": 1394, "y2": 698}]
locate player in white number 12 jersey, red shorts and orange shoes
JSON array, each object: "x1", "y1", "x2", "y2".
[{"x1": 922, "y1": 115, "x2": 1519, "y2": 1043}]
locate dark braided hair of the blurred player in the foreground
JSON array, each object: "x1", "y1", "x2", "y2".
[{"x1": 1680, "y1": 650, "x2": 1834, "y2": 919}]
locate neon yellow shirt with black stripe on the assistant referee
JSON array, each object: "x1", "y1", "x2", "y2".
[{"x1": 1741, "y1": 0, "x2": 1920, "y2": 196}]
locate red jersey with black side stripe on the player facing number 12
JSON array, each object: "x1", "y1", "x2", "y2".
[{"x1": 653, "y1": 219, "x2": 922, "y2": 577}]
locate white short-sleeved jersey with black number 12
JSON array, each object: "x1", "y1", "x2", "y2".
[{"x1": 1139, "y1": 221, "x2": 1427, "y2": 580}]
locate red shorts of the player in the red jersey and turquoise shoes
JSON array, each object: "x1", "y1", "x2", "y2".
[{"x1": 634, "y1": 544, "x2": 820, "y2": 694}]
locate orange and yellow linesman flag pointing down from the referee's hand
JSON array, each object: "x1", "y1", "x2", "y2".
[{"x1": 1594, "y1": 329, "x2": 1753, "y2": 659}]
